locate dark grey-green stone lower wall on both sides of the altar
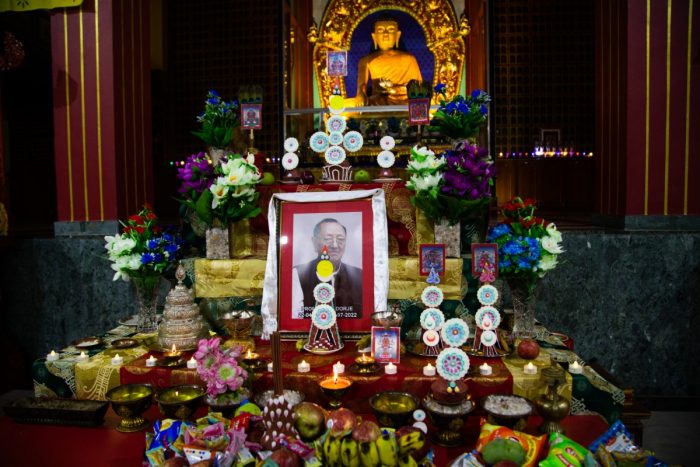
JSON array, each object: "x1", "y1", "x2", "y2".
[{"x1": 0, "y1": 231, "x2": 700, "y2": 396}]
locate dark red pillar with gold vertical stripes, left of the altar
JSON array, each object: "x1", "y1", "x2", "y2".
[{"x1": 51, "y1": 0, "x2": 153, "y2": 222}]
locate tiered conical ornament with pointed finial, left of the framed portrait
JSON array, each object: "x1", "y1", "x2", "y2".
[{"x1": 158, "y1": 264, "x2": 208, "y2": 350}]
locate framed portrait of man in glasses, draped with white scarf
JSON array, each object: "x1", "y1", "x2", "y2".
[{"x1": 261, "y1": 190, "x2": 389, "y2": 338}]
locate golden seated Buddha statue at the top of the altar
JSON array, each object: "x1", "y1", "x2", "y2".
[{"x1": 353, "y1": 19, "x2": 422, "y2": 105}]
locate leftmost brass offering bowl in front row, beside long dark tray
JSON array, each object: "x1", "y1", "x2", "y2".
[{"x1": 106, "y1": 384, "x2": 153, "y2": 433}]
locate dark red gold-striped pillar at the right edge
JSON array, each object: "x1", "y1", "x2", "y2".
[{"x1": 595, "y1": 0, "x2": 700, "y2": 228}]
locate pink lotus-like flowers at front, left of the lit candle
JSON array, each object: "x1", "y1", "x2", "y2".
[{"x1": 194, "y1": 337, "x2": 248, "y2": 402}]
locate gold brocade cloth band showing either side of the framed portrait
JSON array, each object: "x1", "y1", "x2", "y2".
[{"x1": 194, "y1": 256, "x2": 467, "y2": 300}]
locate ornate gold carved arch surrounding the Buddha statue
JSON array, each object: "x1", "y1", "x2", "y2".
[{"x1": 314, "y1": 0, "x2": 471, "y2": 107}]
